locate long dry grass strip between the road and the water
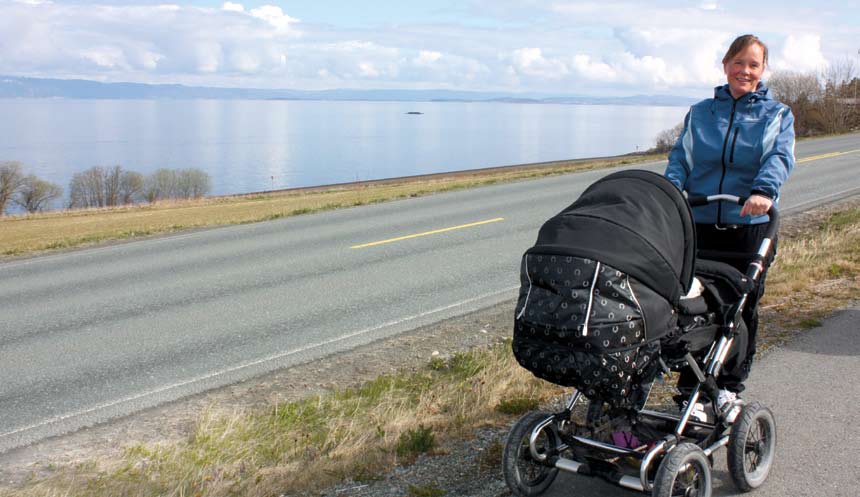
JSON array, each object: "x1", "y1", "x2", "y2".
[{"x1": 0, "y1": 156, "x2": 657, "y2": 256}]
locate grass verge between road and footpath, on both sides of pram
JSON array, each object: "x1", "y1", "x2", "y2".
[{"x1": 2, "y1": 208, "x2": 860, "y2": 497}]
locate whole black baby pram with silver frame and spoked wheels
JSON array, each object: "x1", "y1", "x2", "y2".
[{"x1": 503, "y1": 170, "x2": 778, "y2": 497}]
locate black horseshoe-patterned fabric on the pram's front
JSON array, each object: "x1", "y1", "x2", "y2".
[{"x1": 513, "y1": 253, "x2": 660, "y2": 406}]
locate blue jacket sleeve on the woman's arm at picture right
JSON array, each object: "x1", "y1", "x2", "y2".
[{"x1": 752, "y1": 105, "x2": 794, "y2": 199}]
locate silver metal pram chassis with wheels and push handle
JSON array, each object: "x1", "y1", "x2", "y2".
[{"x1": 505, "y1": 194, "x2": 779, "y2": 496}]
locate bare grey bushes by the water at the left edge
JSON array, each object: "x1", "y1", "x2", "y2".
[{"x1": 0, "y1": 162, "x2": 212, "y2": 216}]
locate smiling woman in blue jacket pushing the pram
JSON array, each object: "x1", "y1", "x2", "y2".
[{"x1": 666, "y1": 35, "x2": 794, "y2": 422}]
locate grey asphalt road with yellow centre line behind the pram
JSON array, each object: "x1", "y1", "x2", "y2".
[{"x1": 0, "y1": 134, "x2": 860, "y2": 451}]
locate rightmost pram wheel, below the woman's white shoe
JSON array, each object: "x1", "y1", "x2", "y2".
[{"x1": 727, "y1": 402, "x2": 776, "y2": 492}]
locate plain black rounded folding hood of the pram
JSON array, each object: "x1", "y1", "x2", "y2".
[{"x1": 529, "y1": 170, "x2": 696, "y2": 306}]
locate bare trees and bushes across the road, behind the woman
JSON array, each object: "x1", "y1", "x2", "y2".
[{"x1": 650, "y1": 60, "x2": 860, "y2": 153}]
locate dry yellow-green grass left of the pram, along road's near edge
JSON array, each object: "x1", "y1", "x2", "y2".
[{"x1": 4, "y1": 345, "x2": 559, "y2": 497}]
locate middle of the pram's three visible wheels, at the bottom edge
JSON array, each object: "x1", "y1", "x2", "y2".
[{"x1": 651, "y1": 443, "x2": 711, "y2": 497}]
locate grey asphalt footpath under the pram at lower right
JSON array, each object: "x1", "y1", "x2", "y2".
[{"x1": 544, "y1": 307, "x2": 860, "y2": 497}]
